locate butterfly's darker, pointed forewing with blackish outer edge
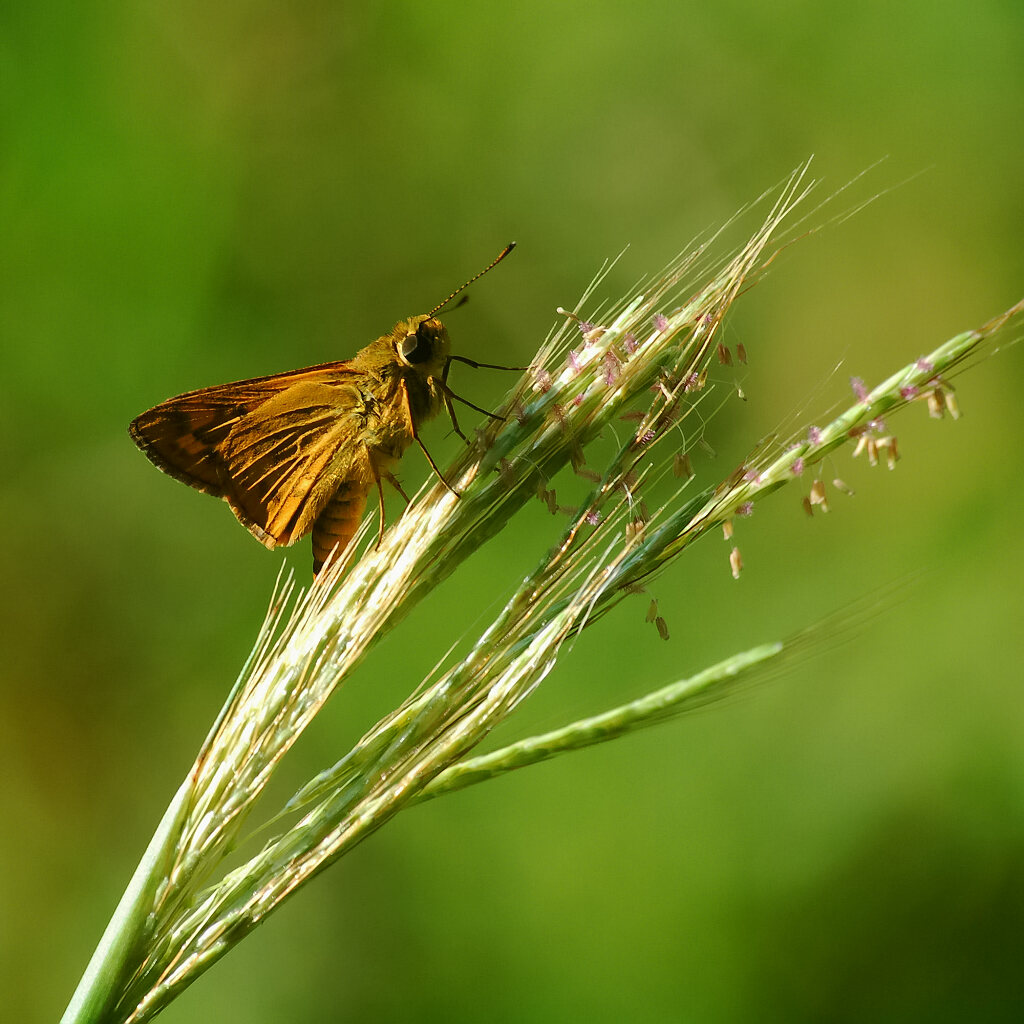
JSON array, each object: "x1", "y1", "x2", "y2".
[{"x1": 128, "y1": 362, "x2": 359, "y2": 498}]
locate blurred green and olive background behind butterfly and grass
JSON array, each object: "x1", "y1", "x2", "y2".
[{"x1": 0, "y1": 0, "x2": 1024, "y2": 1022}]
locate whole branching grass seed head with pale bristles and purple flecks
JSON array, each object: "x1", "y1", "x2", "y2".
[{"x1": 65, "y1": 163, "x2": 1024, "y2": 1022}]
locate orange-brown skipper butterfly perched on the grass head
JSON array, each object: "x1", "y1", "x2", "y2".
[{"x1": 128, "y1": 242, "x2": 523, "y2": 574}]
